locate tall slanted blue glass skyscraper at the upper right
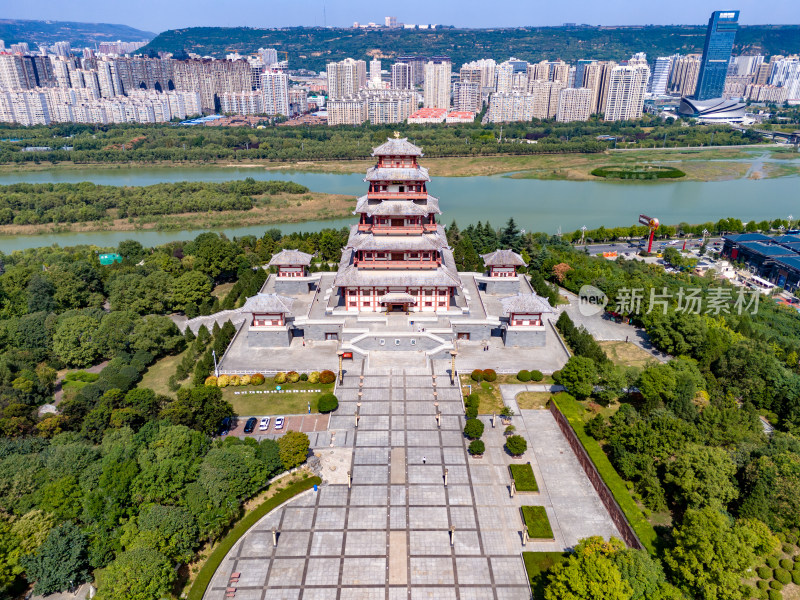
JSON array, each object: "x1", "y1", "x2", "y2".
[{"x1": 694, "y1": 10, "x2": 739, "y2": 100}]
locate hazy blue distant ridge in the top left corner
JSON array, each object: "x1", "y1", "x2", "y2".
[{"x1": 0, "y1": 19, "x2": 156, "y2": 48}]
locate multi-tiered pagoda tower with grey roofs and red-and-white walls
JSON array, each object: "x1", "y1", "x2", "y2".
[{"x1": 334, "y1": 134, "x2": 461, "y2": 312}]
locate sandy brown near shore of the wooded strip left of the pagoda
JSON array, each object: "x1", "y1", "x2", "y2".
[{"x1": 0, "y1": 192, "x2": 355, "y2": 236}]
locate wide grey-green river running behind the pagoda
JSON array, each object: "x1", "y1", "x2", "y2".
[{"x1": 0, "y1": 167, "x2": 800, "y2": 253}]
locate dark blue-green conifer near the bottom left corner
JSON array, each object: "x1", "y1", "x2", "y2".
[{"x1": 22, "y1": 522, "x2": 91, "y2": 595}]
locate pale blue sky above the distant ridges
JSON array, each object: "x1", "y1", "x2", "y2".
[{"x1": 0, "y1": 0, "x2": 800, "y2": 32}]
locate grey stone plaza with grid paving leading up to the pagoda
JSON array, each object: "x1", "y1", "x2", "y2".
[{"x1": 205, "y1": 368, "x2": 613, "y2": 600}]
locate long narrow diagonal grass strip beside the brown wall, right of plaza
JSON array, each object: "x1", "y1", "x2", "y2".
[{"x1": 552, "y1": 393, "x2": 656, "y2": 553}]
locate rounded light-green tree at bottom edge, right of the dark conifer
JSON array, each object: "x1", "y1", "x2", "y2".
[{"x1": 95, "y1": 548, "x2": 175, "y2": 600}]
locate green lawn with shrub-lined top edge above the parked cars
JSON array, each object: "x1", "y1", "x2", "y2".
[{"x1": 222, "y1": 380, "x2": 333, "y2": 416}]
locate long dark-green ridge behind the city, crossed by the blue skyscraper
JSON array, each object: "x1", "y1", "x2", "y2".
[{"x1": 142, "y1": 25, "x2": 800, "y2": 70}]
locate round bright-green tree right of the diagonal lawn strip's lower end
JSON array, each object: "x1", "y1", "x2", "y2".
[{"x1": 664, "y1": 444, "x2": 739, "y2": 510}]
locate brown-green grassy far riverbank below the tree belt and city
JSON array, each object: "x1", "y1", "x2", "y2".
[{"x1": 0, "y1": 145, "x2": 800, "y2": 181}]
